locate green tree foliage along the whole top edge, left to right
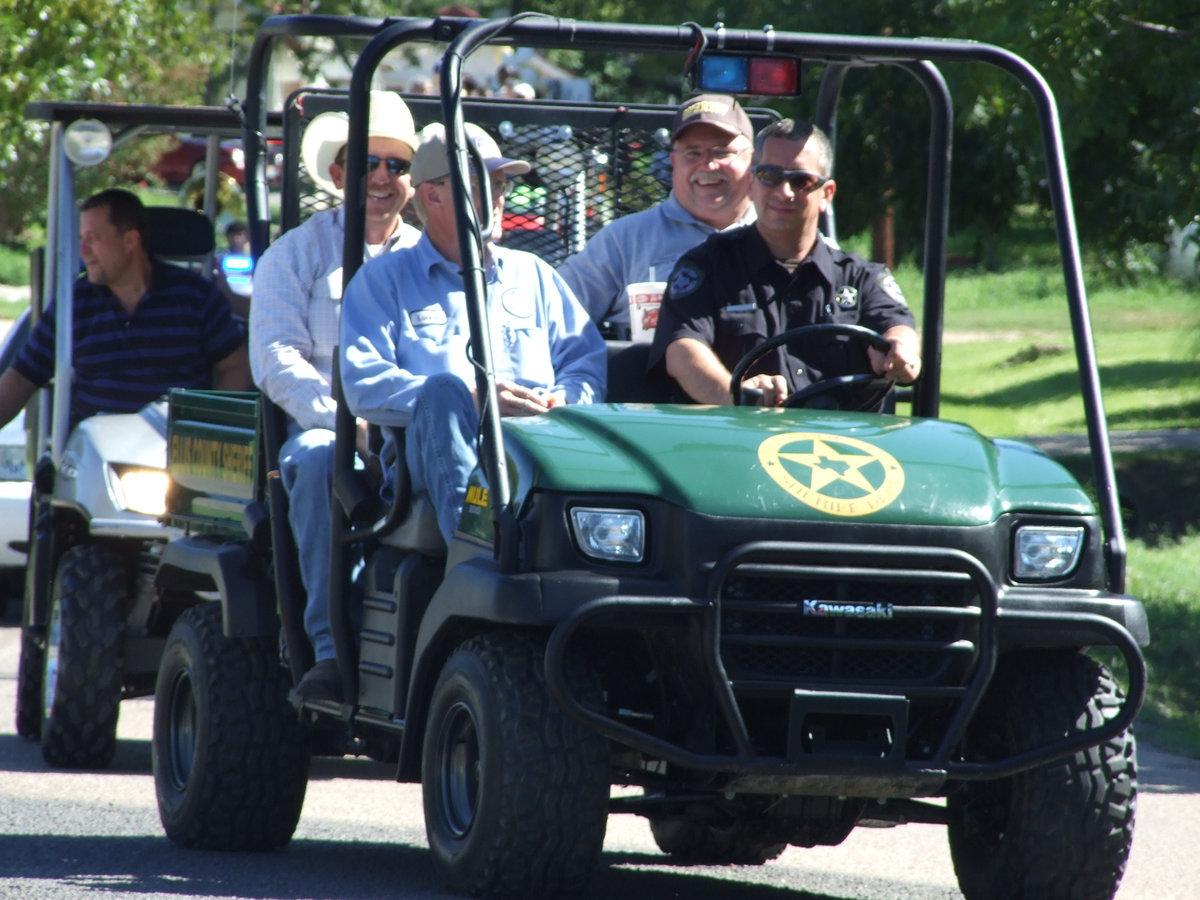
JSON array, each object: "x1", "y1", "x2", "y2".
[{"x1": 0, "y1": 0, "x2": 1200, "y2": 267}]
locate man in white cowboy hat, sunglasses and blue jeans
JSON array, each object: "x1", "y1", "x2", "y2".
[{"x1": 250, "y1": 91, "x2": 420, "y2": 700}]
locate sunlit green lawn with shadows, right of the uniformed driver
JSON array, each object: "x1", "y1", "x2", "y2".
[{"x1": 898, "y1": 266, "x2": 1200, "y2": 437}]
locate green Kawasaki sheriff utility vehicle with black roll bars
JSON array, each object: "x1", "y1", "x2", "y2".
[{"x1": 154, "y1": 16, "x2": 1148, "y2": 900}]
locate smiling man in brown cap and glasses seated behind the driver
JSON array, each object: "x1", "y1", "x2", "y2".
[{"x1": 558, "y1": 94, "x2": 755, "y2": 338}]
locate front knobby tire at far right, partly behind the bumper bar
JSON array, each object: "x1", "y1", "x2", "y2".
[{"x1": 947, "y1": 650, "x2": 1138, "y2": 900}]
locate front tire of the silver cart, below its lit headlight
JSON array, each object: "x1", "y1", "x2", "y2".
[{"x1": 42, "y1": 544, "x2": 127, "y2": 769}]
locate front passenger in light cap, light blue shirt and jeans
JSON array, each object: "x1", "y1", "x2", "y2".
[{"x1": 341, "y1": 124, "x2": 606, "y2": 546}]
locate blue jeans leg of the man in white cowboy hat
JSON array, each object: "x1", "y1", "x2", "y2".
[{"x1": 280, "y1": 426, "x2": 337, "y2": 661}]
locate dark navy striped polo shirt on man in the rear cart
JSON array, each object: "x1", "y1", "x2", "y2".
[{"x1": 13, "y1": 260, "x2": 244, "y2": 426}]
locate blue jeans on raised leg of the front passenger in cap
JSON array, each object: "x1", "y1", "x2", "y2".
[{"x1": 404, "y1": 374, "x2": 479, "y2": 547}]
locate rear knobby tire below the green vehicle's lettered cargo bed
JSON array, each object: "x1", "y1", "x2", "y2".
[{"x1": 152, "y1": 602, "x2": 310, "y2": 851}]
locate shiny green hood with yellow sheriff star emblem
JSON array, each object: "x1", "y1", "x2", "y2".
[{"x1": 504, "y1": 403, "x2": 1094, "y2": 526}]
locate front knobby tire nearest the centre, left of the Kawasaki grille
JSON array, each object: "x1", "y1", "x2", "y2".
[{"x1": 421, "y1": 635, "x2": 610, "y2": 898}]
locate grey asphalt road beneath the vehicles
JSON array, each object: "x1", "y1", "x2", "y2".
[{"x1": 0, "y1": 623, "x2": 1200, "y2": 900}]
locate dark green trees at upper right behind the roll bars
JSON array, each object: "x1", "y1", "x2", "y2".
[{"x1": 537, "y1": 0, "x2": 1200, "y2": 271}]
